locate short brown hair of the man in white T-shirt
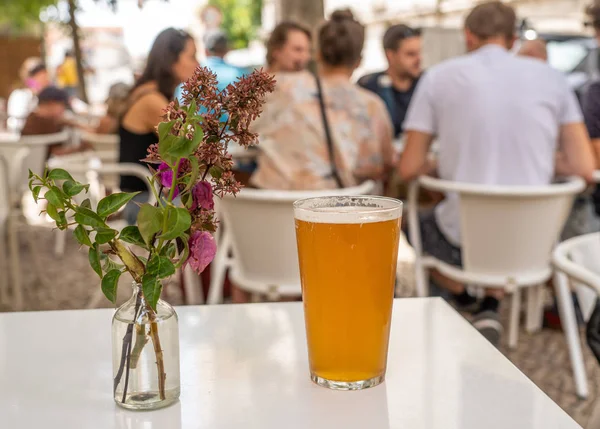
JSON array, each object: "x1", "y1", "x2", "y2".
[{"x1": 465, "y1": 1, "x2": 517, "y2": 40}]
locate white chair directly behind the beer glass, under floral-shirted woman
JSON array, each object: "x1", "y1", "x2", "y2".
[{"x1": 208, "y1": 181, "x2": 375, "y2": 304}]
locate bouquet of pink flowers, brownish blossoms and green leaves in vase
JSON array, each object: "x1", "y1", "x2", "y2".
[{"x1": 29, "y1": 67, "x2": 275, "y2": 404}]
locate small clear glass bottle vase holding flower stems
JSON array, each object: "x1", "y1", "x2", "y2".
[{"x1": 112, "y1": 283, "x2": 181, "y2": 410}]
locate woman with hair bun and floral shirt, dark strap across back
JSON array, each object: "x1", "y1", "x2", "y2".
[{"x1": 251, "y1": 10, "x2": 394, "y2": 190}]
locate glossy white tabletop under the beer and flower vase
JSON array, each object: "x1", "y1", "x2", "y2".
[{"x1": 0, "y1": 298, "x2": 580, "y2": 429}]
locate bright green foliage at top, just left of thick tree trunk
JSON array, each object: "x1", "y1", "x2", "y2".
[{"x1": 208, "y1": 0, "x2": 262, "y2": 49}]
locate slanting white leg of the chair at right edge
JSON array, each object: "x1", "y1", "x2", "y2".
[{"x1": 554, "y1": 272, "x2": 589, "y2": 399}]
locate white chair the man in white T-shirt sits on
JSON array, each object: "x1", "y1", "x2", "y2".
[{"x1": 408, "y1": 177, "x2": 585, "y2": 348}]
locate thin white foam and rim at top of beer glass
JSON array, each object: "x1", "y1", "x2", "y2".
[{"x1": 294, "y1": 196, "x2": 402, "y2": 224}]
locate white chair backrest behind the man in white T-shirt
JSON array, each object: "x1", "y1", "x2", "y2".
[{"x1": 419, "y1": 177, "x2": 585, "y2": 281}]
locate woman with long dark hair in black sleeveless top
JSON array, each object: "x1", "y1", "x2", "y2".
[{"x1": 119, "y1": 28, "x2": 198, "y2": 224}]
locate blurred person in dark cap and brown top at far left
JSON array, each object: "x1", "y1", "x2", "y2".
[{"x1": 21, "y1": 86, "x2": 91, "y2": 157}]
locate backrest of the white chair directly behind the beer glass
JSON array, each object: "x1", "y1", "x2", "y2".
[{"x1": 217, "y1": 182, "x2": 375, "y2": 290}]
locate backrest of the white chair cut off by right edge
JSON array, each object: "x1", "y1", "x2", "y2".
[{"x1": 552, "y1": 232, "x2": 600, "y2": 321}]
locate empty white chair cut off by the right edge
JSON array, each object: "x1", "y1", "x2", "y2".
[{"x1": 552, "y1": 233, "x2": 600, "y2": 398}]
